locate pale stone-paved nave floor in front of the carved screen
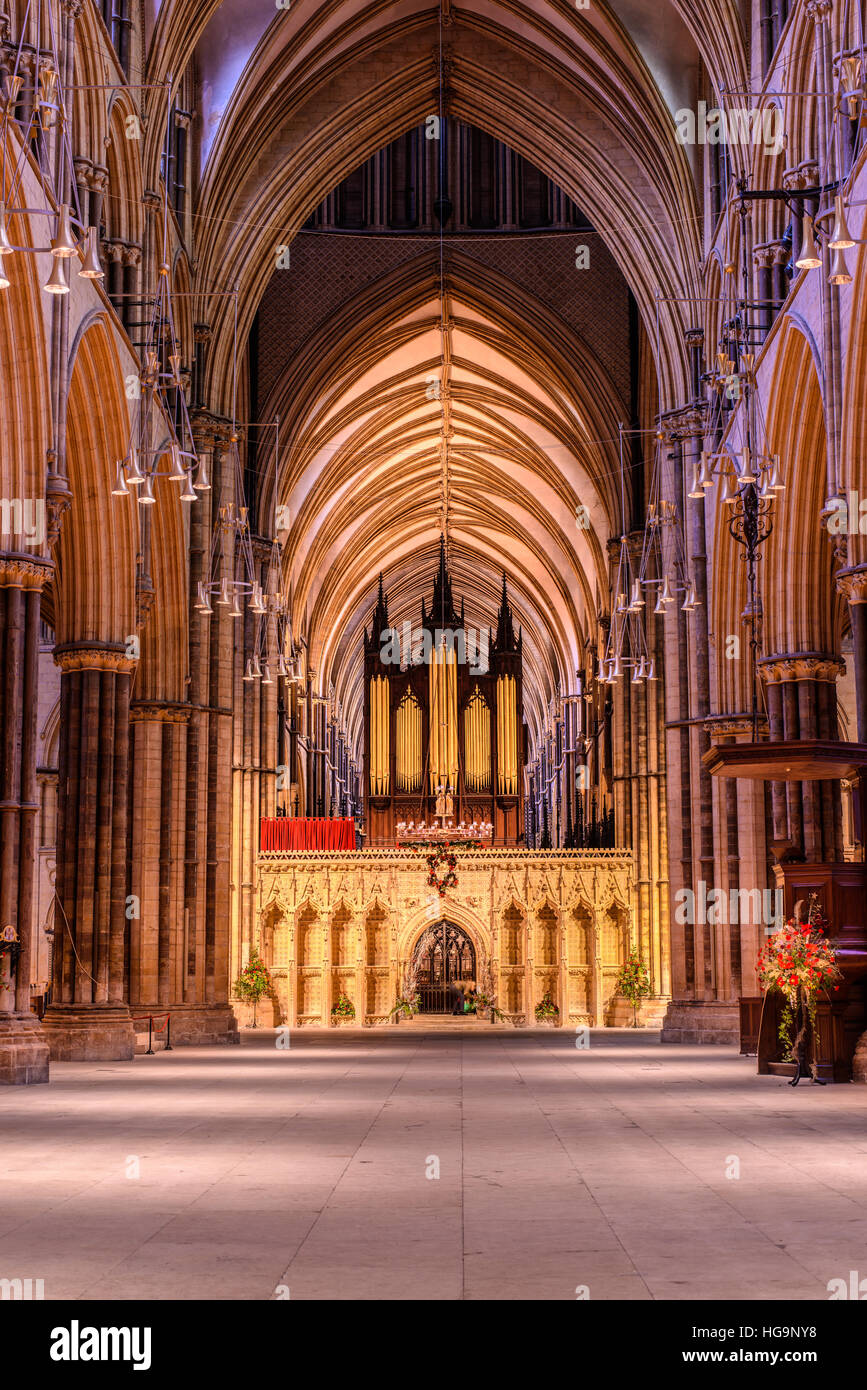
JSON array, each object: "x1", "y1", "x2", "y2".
[{"x1": 0, "y1": 1024, "x2": 867, "y2": 1300}]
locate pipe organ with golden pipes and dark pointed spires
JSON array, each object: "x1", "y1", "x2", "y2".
[{"x1": 364, "y1": 543, "x2": 527, "y2": 847}]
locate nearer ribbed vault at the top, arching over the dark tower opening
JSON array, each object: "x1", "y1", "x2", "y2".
[{"x1": 166, "y1": 0, "x2": 708, "y2": 403}]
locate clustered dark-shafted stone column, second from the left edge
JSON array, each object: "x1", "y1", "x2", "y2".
[{"x1": 43, "y1": 642, "x2": 135, "y2": 1062}]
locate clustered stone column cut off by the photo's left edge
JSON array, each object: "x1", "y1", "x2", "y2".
[{"x1": 0, "y1": 555, "x2": 51, "y2": 1084}]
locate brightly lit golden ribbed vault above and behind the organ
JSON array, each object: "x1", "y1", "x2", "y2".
[{"x1": 255, "y1": 249, "x2": 627, "y2": 751}]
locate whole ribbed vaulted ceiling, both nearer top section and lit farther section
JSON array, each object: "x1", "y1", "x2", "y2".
[{"x1": 140, "y1": 0, "x2": 745, "y2": 738}]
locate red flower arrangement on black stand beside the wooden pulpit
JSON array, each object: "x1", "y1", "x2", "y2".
[{"x1": 756, "y1": 894, "x2": 841, "y2": 1086}]
